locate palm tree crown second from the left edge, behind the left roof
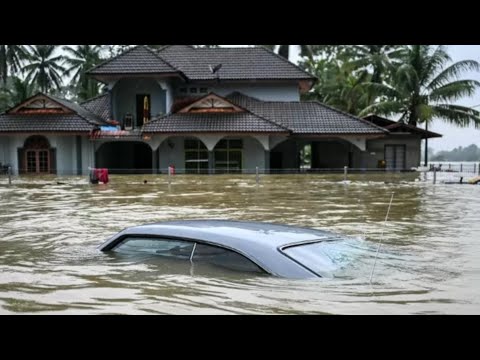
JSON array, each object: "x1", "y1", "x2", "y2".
[{"x1": 24, "y1": 45, "x2": 65, "y2": 93}]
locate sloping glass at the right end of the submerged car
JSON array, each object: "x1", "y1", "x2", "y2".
[{"x1": 282, "y1": 239, "x2": 351, "y2": 277}]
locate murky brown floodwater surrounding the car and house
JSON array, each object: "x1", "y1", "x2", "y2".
[{"x1": 0, "y1": 173, "x2": 480, "y2": 314}]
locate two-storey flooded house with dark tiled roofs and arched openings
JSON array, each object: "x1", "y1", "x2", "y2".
[{"x1": 0, "y1": 45, "x2": 440, "y2": 175}]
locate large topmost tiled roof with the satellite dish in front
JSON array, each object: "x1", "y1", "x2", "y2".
[{"x1": 157, "y1": 45, "x2": 314, "y2": 80}]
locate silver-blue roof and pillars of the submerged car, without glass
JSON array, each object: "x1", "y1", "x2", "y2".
[{"x1": 100, "y1": 220, "x2": 341, "y2": 278}]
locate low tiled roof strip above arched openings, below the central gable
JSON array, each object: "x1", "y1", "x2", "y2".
[{"x1": 143, "y1": 112, "x2": 288, "y2": 133}]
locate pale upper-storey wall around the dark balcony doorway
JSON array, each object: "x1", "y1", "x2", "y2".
[{"x1": 112, "y1": 79, "x2": 167, "y2": 123}]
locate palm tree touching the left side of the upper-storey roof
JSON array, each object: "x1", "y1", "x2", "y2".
[{"x1": 63, "y1": 45, "x2": 102, "y2": 100}]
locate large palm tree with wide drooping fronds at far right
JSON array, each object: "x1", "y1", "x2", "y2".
[{"x1": 362, "y1": 45, "x2": 480, "y2": 166}]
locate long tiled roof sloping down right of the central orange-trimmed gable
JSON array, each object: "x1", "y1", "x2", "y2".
[{"x1": 227, "y1": 92, "x2": 388, "y2": 135}]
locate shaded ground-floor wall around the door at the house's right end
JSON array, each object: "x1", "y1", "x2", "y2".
[{"x1": 364, "y1": 134, "x2": 422, "y2": 169}]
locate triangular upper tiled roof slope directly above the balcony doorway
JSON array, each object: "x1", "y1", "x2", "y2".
[{"x1": 87, "y1": 46, "x2": 178, "y2": 75}]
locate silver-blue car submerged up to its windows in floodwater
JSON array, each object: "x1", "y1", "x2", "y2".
[{"x1": 99, "y1": 220, "x2": 356, "y2": 278}]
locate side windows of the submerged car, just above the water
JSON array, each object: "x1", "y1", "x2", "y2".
[{"x1": 113, "y1": 237, "x2": 264, "y2": 273}]
